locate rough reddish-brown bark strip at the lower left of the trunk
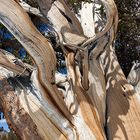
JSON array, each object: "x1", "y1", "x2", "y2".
[{"x1": 0, "y1": 69, "x2": 42, "y2": 140}]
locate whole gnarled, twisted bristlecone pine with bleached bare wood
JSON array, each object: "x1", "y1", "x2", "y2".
[{"x1": 0, "y1": 0, "x2": 140, "y2": 140}]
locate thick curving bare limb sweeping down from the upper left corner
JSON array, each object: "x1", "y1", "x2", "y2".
[{"x1": 0, "y1": 0, "x2": 72, "y2": 121}]
